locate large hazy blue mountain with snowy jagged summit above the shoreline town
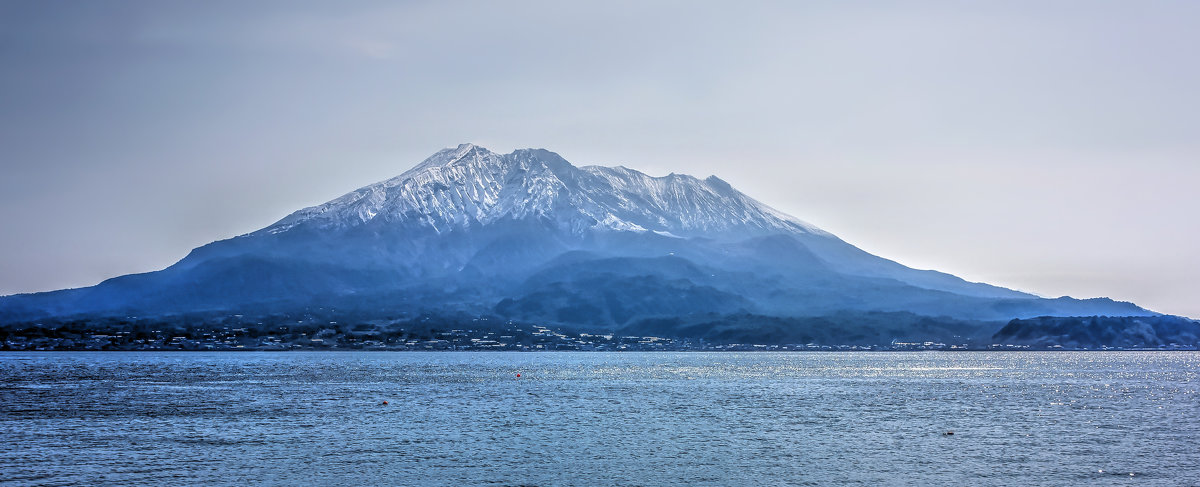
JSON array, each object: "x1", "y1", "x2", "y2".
[{"x1": 0, "y1": 144, "x2": 1156, "y2": 343}]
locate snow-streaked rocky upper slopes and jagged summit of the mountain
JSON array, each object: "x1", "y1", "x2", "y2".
[{"x1": 260, "y1": 144, "x2": 829, "y2": 238}]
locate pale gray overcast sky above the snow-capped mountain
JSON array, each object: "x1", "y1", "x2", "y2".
[{"x1": 0, "y1": 0, "x2": 1200, "y2": 317}]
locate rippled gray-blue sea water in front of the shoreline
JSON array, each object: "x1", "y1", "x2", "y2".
[{"x1": 0, "y1": 351, "x2": 1200, "y2": 486}]
